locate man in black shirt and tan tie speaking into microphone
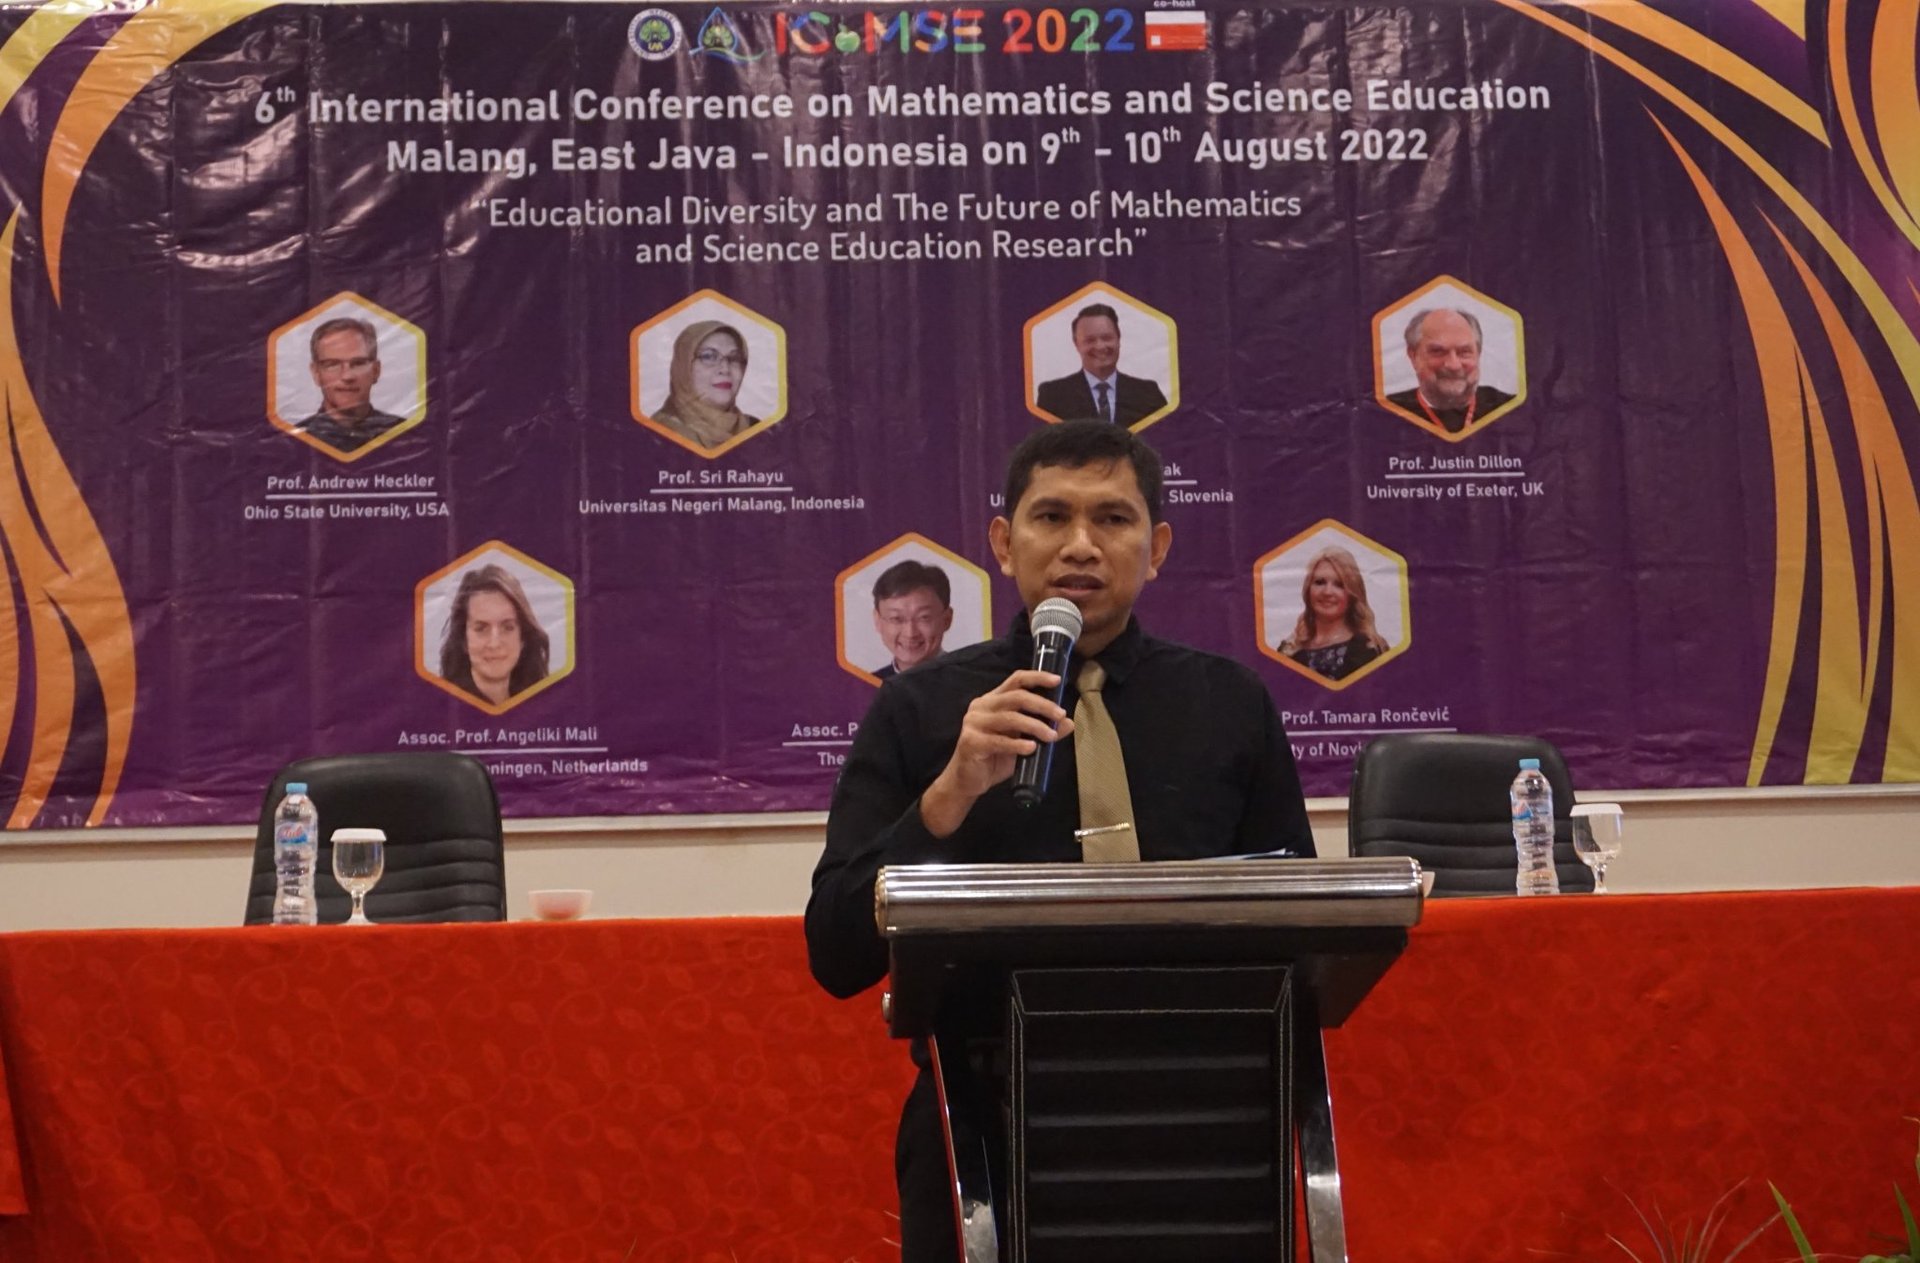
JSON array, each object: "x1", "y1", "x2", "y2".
[{"x1": 806, "y1": 420, "x2": 1313, "y2": 1263}]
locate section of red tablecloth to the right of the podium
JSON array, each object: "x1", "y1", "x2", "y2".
[{"x1": 1327, "y1": 889, "x2": 1920, "y2": 1263}]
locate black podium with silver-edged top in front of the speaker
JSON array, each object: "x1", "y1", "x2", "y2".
[{"x1": 874, "y1": 858, "x2": 1423, "y2": 1263}]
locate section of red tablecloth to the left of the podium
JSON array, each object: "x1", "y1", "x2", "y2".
[{"x1": 0, "y1": 919, "x2": 912, "y2": 1263}]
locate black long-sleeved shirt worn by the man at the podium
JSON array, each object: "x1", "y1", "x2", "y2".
[{"x1": 806, "y1": 614, "x2": 1313, "y2": 996}]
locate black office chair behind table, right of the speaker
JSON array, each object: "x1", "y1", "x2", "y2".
[{"x1": 1346, "y1": 733, "x2": 1594, "y2": 894}]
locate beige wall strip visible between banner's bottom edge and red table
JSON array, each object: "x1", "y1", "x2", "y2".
[{"x1": 0, "y1": 787, "x2": 1920, "y2": 931}]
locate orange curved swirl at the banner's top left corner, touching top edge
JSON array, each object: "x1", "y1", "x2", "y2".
[{"x1": 40, "y1": 0, "x2": 276, "y2": 303}]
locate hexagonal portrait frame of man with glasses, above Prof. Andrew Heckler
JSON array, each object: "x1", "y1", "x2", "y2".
[{"x1": 267, "y1": 290, "x2": 426, "y2": 463}]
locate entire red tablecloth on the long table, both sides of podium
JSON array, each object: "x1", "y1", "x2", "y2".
[{"x1": 0, "y1": 891, "x2": 1920, "y2": 1263}]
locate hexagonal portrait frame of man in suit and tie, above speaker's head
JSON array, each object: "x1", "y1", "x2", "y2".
[{"x1": 1021, "y1": 282, "x2": 1181, "y2": 434}]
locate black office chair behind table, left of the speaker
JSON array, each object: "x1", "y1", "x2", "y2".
[{"x1": 246, "y1": 754, "x2": 507, "y2": 925}]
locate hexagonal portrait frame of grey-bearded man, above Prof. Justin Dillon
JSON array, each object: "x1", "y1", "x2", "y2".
[{"x1": 1373, "y1": 276, "x2": 1526, "y2": 443}]
